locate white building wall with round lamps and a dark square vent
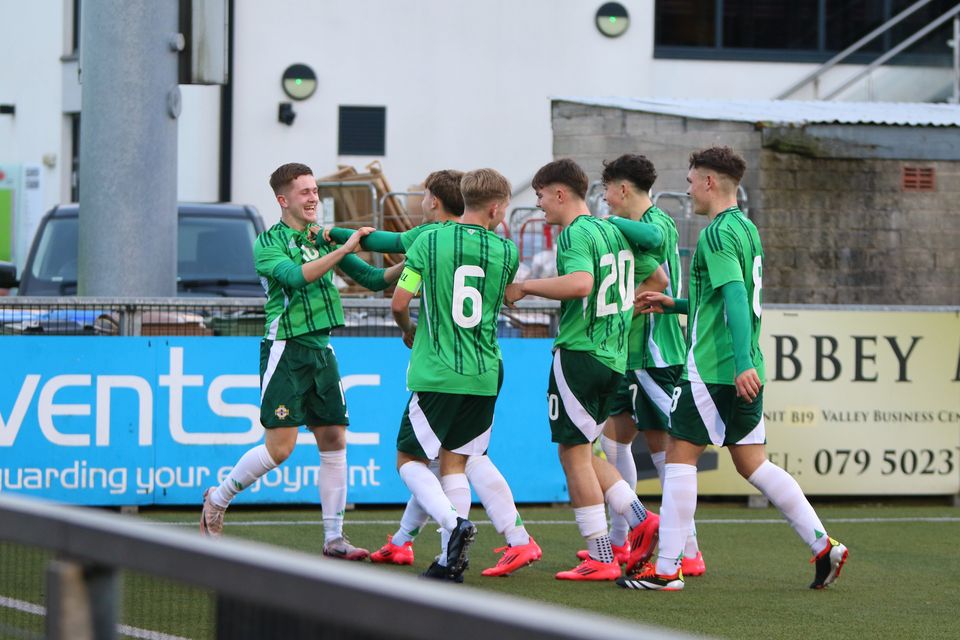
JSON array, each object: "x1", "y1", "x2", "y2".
[{"x1": 0, "y1": 0, "x2": 944, "y2": 229}]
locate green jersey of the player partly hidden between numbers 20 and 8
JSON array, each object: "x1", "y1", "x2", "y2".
[{"x1": 627, "y1": 206, "x2": 686, "y2": 369}]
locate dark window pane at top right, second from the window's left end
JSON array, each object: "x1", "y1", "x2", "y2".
[{"x1": 723, "y1": 0, "x2": 818, "y2": 50}]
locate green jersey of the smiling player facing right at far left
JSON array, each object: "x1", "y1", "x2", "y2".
[{"x1": 253, "y1": 222, "x2": 343, "y2": 340}]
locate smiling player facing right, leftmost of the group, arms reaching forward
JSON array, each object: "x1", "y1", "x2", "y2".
[{"x1": 200, "y1": 163, "x2": 402, "y2": 560}]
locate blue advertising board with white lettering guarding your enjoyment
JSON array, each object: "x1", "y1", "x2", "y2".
[{"x1": 0, "y1": 336, "x2": 567, "y2": 505}]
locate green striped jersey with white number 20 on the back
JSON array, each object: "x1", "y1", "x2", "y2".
[{"x1": 553, "y1": 215, "x2": 636, "y2": 373}]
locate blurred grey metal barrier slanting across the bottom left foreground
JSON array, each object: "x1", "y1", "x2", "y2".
[{"x1": 0, "y1": 495, "x2": 689, "y2": 640}]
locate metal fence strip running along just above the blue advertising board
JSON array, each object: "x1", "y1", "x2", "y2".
[{"x1": 0, "y1": 296, "x2": 559, "y2": 338}]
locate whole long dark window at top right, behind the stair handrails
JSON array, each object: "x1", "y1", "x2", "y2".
[{"x1": 654, "y1": 0, "x2": 955, "y2": 65}]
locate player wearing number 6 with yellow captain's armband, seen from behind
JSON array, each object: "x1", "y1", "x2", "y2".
[{"x1": 392, "y1": 169, "x2": 540, "y2": 581}]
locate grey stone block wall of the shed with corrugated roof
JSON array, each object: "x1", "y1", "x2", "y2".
[{"x1": 553, "y1": 102, "x2": 960, "y2": 305}]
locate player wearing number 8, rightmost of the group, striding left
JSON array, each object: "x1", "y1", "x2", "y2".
[{"x1": 632, "y1": 147, "x2": 847, "y2": 591}]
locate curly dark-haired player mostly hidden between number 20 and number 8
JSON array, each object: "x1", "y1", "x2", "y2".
[{"x1": 600, "y1": 154, "x2": 706, "y2": 576}]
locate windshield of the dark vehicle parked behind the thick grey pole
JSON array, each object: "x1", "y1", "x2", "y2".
[{"x1": 31, "y1": 216, "x2": 257, "y2": 293}]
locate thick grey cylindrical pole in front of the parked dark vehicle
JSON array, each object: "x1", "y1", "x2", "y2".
[{"x1": 78, "y1": 0, "x2": 184, "y2": 297}]
